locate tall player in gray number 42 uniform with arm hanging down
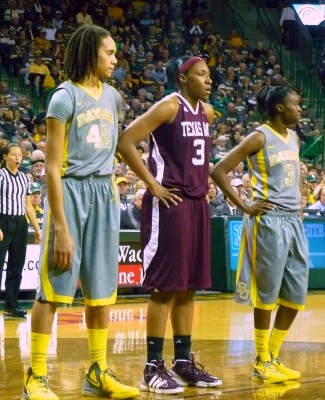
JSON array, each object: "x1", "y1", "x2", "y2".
[{"x1": 22, "y1": 25, "x2": 139, "y2": 400}]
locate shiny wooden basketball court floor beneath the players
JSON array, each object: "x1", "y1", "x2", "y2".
[{"x1": 0, "y1": 292, "x2": 325, "y2": 400}]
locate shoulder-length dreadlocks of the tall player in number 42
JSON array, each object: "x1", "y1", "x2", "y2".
[{"x1": 64, "y1": 25, "x2": 111, "y2": 82}]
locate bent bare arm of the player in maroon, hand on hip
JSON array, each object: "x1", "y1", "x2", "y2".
[{"x1": 118, "y1": 96, "x2": 181, "y2": 207}]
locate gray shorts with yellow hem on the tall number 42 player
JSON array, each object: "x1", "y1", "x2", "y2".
[{"x1": 36, "y1": 176, "x2": 120, "y2": 306}]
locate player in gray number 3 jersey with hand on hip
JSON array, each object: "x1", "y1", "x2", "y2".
[{"x1": 211, "y1": 86, "x2": 308, "y2": 383}]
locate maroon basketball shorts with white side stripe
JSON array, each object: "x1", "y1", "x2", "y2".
[{"x1": 141, "y1": 192, "x2": 211, "y2": 292}]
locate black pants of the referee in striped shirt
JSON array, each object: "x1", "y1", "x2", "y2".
[{"x1": 0, "y1": 214, "x2": 28, "y2": 310}]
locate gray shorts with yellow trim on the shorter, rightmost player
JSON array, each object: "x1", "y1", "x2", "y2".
[{"x1": 234, "y1": 211, "x2": 309, "y2": 310}]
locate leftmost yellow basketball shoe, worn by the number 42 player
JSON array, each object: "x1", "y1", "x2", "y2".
[{"x1": 21, "y1": 367, "x2": 59, "y2": 400}]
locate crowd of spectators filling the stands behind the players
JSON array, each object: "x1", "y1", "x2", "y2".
[{"x1": 0, "y1": 0, "x2": 325, "y2": 229}]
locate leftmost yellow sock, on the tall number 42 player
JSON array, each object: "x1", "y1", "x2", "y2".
[{"x1": 30, "y1": 332, "x2": 51, "y2": 376}]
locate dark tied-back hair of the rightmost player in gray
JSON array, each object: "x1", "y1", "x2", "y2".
[{"x1": 256, "y1": 86, "x2": 294, "y2": 121}]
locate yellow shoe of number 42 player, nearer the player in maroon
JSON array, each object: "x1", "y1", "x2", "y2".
[{"x1": 82, "y1": 362, "x2": 140, "y2": 399}]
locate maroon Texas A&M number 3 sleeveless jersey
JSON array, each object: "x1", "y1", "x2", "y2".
[{"x1": 149, "y1": 93, "x2": 211, "y2": 198}]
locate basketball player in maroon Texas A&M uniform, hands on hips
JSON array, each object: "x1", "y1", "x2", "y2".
[{"x1": 119, "y1": 57, "x2": 221, "y2": 394}]
